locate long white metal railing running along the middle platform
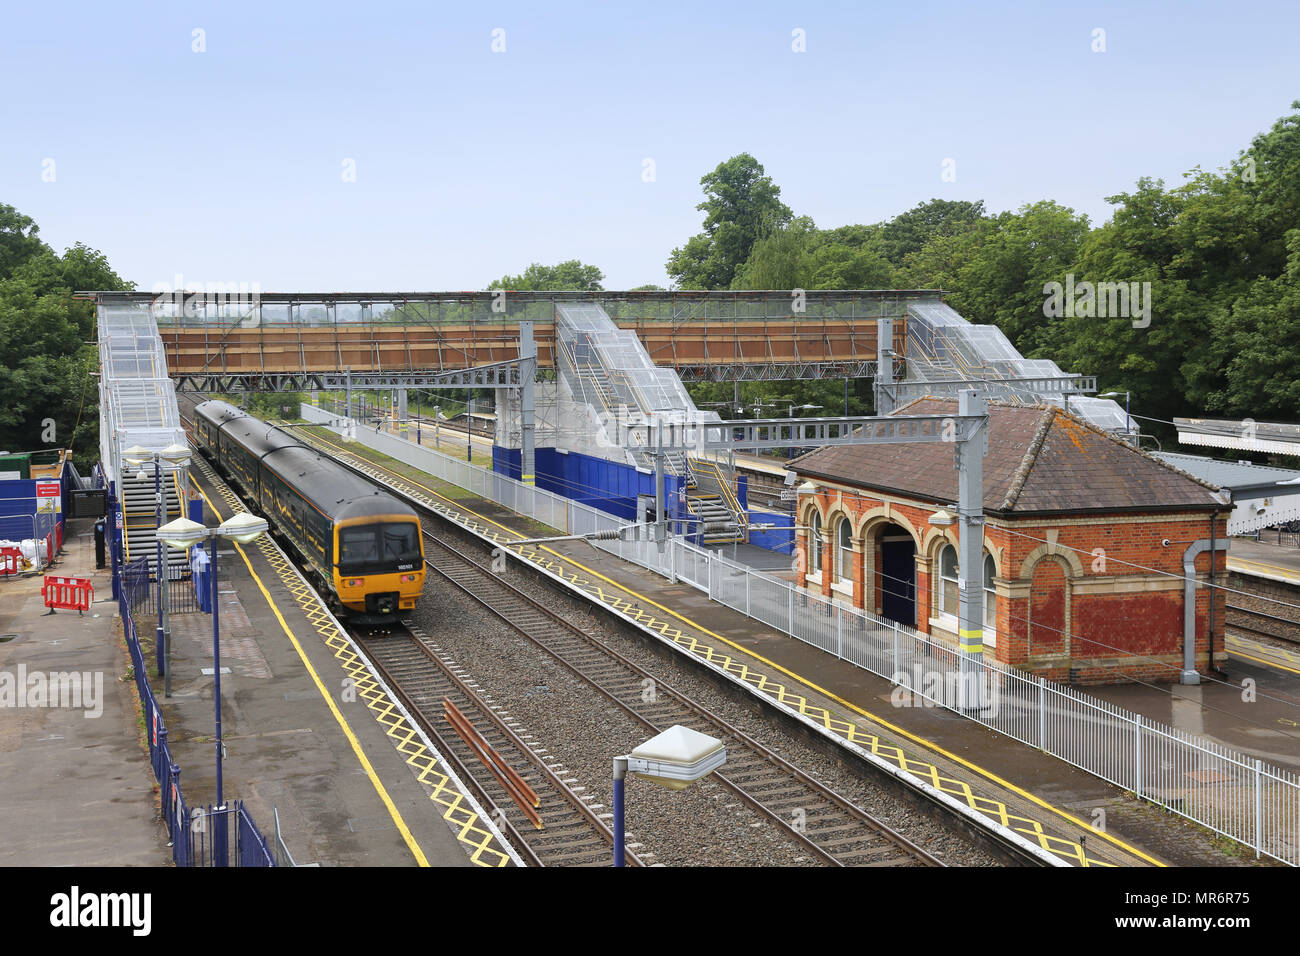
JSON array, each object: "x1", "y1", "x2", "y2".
[{"x1": 303, "y1": 405, "x2": 1300, "y2": 866}]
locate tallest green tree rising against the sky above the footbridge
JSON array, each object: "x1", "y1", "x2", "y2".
[{"x1": 667, "y1": 152, "x2": 793, "y2": 289}]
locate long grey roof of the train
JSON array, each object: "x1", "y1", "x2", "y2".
[{"x1": 195, "y1": 401, "x2": 415, "y2": 522}]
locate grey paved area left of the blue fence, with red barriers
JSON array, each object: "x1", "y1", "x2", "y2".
[{"x1": 0, "y1": 519, "x2": 172, "y2": 866}]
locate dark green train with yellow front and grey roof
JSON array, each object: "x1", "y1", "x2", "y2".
[{"x1": 194, "y1": 401, "x2": 425, "y2": 623}]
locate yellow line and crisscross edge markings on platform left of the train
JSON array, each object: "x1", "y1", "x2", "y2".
[{"x1": 195, "y1": 459, "x2": 511, "y2": 866}]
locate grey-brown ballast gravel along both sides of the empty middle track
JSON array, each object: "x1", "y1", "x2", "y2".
[{"x1": 412, "y1": 522, "x2": 998, "y2": 866}]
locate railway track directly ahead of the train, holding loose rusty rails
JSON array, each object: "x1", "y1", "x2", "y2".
[{"x1": 350, "y1": 626, "x2": 645, "y2": 866}]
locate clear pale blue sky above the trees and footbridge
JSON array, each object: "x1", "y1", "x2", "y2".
[{"x1": 0, "y1": 0, "x2": 1300, "y2": 291}]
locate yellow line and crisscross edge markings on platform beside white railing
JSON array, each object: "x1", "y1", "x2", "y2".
[{"x1": 289, "y1": 434, "x2": 1166, "y2": 866}]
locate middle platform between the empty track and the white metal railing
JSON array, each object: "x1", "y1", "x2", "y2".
[{"x1": 287, "y1": 429, "x2": 1289, "y2": 866}]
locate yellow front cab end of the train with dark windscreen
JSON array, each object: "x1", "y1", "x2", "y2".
[{"x1": 334, "y1": 515, "x2": 425, "y2": 617}]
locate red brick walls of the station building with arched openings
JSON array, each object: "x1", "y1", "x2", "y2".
[{"x1": 798, "y1": 485, "x2": 1227, "y2": 683}]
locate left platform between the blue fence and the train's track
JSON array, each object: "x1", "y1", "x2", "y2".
[{"x1": 143, "y1": 462, "x2": 510, "y2": 866}]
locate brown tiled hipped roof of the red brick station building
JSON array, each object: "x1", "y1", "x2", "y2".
[{"x1": 790, "y1": 398, "x2": 1222, "y2": 514}]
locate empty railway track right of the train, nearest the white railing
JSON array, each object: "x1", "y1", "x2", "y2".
[{"x1": 425, "y1": 531, "x2": 944, "y2": 866}]
